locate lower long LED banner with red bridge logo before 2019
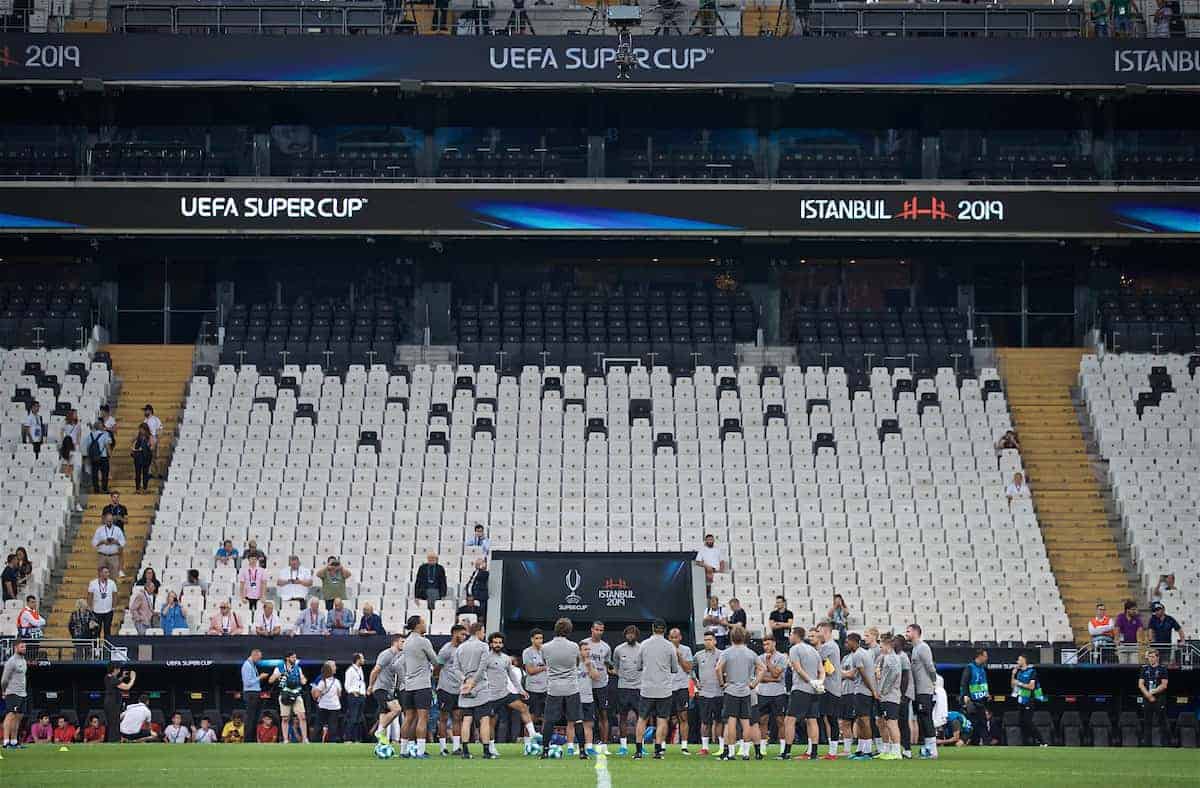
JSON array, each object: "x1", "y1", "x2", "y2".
[{"x1": 0, "y1": 182, "x2": 1200, "y2": 239}]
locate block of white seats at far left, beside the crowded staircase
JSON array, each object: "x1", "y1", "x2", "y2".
[{"x1": 0, "y1": 348, "x2": 110, "y2": 636}]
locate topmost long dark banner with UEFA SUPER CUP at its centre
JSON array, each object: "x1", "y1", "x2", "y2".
[{"x1": 0, "y1": 34, "x2": 1200, "y2": 90}]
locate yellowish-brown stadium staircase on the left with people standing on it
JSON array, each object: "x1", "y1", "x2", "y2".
[{"x1": 46, "y1": 344, "x2": 192, "y2": 637}]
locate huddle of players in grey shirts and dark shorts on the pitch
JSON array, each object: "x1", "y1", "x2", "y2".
[{"x1": 367, "y1": 615, "x2": 937, "y2": 760}]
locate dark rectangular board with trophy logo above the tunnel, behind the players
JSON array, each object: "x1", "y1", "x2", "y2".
[{"x1": 492, "y1": 552, "x2": 694, "y2": 626}]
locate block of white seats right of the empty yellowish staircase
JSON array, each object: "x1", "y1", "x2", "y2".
[{"x1": 1079, "y1": 353, "x2": 1200, "y2": 621}]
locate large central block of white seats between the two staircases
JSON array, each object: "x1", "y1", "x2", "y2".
[{"x1": 129, "y1": 352, "x2": 1069, "y2": 642}]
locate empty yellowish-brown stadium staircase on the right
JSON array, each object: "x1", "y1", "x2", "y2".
[{"x1": 1000, "y1": 348, "x2": 1136, "y2": 643}]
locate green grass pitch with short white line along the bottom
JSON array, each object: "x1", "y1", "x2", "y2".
[{"x1": 0, "y1": 744, "x2": 1200, "y2": 788}]
